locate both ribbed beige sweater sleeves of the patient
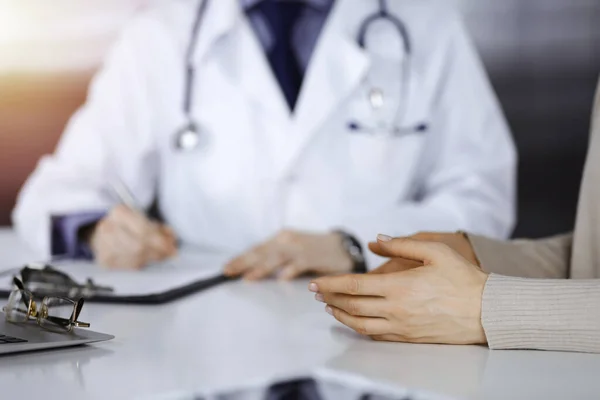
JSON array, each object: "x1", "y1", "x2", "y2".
[{"x1": 469, "y1": 234, "x2": 600, "y2": 353}]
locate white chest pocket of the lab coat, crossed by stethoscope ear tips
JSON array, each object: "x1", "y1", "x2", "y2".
[{"x1": 347, "y1": 65, "x2": 431, "y2": 189}]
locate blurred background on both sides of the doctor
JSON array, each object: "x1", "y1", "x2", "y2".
[{"x1": 0, "y1": 0, "x2": 600, "y2": 237}]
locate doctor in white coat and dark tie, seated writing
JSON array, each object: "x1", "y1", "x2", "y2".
[{"x1": 13, "y1": 0, "x2": 516, "y2": 279}]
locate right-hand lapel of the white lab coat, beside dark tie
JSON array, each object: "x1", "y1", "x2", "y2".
[{"x1": 282, "y1": 1, "x2": 370, "y2": 174}]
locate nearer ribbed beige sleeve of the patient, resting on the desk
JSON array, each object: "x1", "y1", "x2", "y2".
[{"x1": 481, "y1": 274, "x2": 600, "y2": 353}]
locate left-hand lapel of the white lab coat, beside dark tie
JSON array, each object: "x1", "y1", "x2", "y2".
[{"x1": 200, "y1": 0, "x2": 290, "y2": 119}]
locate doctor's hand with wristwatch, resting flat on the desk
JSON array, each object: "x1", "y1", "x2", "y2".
[{"x1": 224, "y1": 231, "x2": 353, "y2": 280}]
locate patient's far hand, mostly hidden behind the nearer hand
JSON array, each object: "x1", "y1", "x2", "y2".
[{"x1": 369, "y1": 232, "x2": 479, "y2": 274}]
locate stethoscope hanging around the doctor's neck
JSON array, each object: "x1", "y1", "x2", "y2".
[{"x1": 175, "y1": 0, "x2": 428, "y2": 151}]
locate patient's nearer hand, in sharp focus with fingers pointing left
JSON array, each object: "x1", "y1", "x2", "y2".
[{"x1": 309, "y1": 236, "x2": 488, "y2": 344}]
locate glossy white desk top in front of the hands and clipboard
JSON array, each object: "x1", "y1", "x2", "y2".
[{"x1": 0, "y1": 230, "x2": 600, "y2": 400}]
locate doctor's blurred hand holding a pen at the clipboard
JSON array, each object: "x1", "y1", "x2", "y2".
[{"x1": 88, "y1": 205, "x2": 177, "y2": 269}]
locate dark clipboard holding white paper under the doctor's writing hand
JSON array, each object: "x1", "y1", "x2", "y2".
[{"x1": 0, "y1": 251, "x2": 235, "y2": 305}]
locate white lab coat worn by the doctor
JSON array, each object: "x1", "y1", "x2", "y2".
[{"x1": 13, "y1": 0, "x2": 516, "y2": 267}]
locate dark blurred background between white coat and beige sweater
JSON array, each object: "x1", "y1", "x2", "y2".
[{"x1": 458, "y1": 0, "x2": 600, "y2": 237}]
